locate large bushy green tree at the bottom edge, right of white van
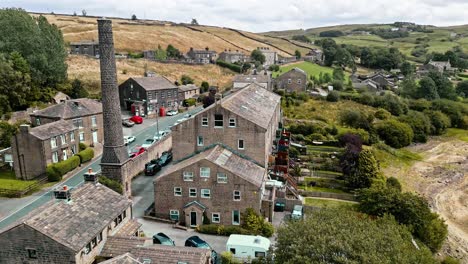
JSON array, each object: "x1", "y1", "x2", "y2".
[{"x1": 275, "y1": 209, "x2": 438, "y2": 264}]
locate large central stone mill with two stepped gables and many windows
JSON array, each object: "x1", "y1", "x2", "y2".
[{"x1": 154, "y1": 83, "x2": 281, "y2": 227}]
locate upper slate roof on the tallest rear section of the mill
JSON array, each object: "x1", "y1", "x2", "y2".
[{"x1": 221, "y1": 83, "x2": 281, "y2": 129}]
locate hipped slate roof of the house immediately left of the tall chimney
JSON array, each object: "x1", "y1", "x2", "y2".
[{"x1": 31, "y1": 98, "x2": 102, "y2": 119}]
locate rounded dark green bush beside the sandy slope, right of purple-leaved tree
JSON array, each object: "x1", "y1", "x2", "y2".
[{"x1": 375, "y1": 119, "x2": 414, "y2": 148}]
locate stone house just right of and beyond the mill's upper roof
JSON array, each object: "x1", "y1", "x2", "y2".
[{"x1": 275, "y1": 68, "x2": 307, "y2": 93}]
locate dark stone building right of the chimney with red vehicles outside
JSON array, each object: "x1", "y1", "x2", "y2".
[{"x1": 119, "y1": 75, "x2": 179, "y2": 116}]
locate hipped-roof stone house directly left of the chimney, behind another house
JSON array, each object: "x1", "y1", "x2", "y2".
[{"x1": 30, "y1": 98, "x2": 104, "y2": 146}]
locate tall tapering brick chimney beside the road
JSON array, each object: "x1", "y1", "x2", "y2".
[{"x1": 98, "y1": 19, "x2": 130, "y2": 193}]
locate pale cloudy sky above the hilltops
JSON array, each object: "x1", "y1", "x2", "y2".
[{"x1": 0, "y1": 0, "x2": 468, "y2": 32}]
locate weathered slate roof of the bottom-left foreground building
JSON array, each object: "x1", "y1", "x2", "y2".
[{"x1": 14, "y1": 183, "x2": 132, "y2": 252}]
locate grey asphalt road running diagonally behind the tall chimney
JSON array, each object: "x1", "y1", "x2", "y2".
[{"x1": 0, "y1": 107, "x2": 202, "y2": 230}]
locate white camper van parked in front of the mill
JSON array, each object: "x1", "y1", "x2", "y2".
[{"x1": 226, "y1": 235, "x2": 270, "y2": 261}]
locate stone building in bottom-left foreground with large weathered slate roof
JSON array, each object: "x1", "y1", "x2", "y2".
[{"x1": 0, "y1": 175, "x2": 140, "y2": 264}]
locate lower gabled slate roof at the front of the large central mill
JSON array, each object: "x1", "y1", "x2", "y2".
[{"x1": 155, "y1": 145, "x2": 266, "y2": 188}]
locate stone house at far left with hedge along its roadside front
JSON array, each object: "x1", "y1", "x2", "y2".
[{"x1": 11, "y1": 120, "x2": 79, "y2": 180}]
